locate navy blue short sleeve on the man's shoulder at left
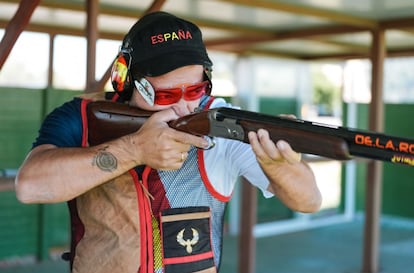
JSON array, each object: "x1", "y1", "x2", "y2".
[{"x1": 33, "y1": 98, "x2": 82, "y2": 148}]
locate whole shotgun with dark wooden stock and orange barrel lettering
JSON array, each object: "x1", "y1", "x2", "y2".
[{"x1": 87, "y1": 101, "x2": 414, "y2": 166}]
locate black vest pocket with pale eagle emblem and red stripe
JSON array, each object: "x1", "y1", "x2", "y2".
[{"x1": 160, "y1": 207, "x2": 216, "y2": 273}]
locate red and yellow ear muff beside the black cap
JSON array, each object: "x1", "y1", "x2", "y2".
[{"x1": 111, "y1": 50, "x2": 131, "y2": 95}]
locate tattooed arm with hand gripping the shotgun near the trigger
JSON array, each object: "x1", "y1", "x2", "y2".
[{"x1": 16, "y1": 110, "x2": 208, "y2": 203}]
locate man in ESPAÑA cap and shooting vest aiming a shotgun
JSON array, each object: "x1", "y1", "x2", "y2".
[{"x1": 16, "y1": 12, "x2": 321, "y2": 273}]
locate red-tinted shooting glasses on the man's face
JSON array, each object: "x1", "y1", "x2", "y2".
[{"x1": 154, "y1": 81, "x2": 210, "y2": 105}]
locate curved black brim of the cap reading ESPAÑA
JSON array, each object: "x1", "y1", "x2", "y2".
[{"x1": 134, "y1": 51, "x2": 212, "y2": 77}]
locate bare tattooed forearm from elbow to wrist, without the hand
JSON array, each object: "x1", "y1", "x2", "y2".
[{"x1": 16, "y1": 141, "x2": 138, "y2": 203}]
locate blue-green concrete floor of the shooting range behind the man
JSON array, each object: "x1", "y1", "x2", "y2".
[{"x1": 0, "y1": 212, "x2": 414, "y2": 273}]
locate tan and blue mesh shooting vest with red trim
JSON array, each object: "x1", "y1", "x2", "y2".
[{"x1": 68, "y1": 97, "x2": 229, "y2": 273}]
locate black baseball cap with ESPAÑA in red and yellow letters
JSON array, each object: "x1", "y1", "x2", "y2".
[{"x1": 122, "y1": 11, "x2": 213, "y2": 76}]
